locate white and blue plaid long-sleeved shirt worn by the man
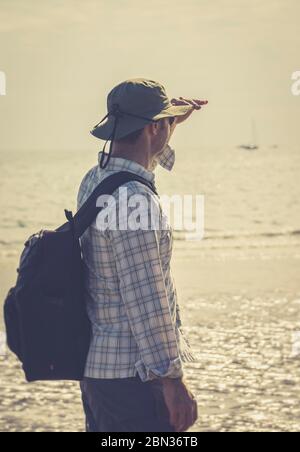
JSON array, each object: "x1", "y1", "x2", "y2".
[{"x1": 77, "y1": 145, "x2": 198, "y2": 381}]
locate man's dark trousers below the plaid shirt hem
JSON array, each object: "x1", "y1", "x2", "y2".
[{"x1": 80, "y1": 374, "x2": 175, "y2": 432}]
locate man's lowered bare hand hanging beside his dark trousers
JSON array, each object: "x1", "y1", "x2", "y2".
[{"x1": 162, "y1": 378, "x2": 198, "y2": 432}]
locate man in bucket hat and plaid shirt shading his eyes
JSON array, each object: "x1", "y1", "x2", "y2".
[{"x1": 78, "y1": 78, "x2": 207, "y2": 432}]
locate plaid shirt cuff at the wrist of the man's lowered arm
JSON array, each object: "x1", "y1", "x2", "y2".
[{"x1": 135, "y1": 357, "x2": 183, "y2": 382}]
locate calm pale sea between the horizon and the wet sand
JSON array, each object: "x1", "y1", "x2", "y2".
[{"x1": 0, "y1": 146, "x2": 300, "y2": 259}]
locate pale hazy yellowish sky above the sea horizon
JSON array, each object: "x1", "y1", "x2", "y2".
[{"x1": 0, "y1": 0, "x2": 300, "y2": 150}]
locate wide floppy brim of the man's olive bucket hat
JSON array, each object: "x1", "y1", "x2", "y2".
[{"x1": 90, "y1": 105, "x2": 193, "y2": 140}]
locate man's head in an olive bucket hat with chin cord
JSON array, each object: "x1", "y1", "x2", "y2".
[{"x1": 91, "y1": 78, "x2": 191, "y2": 168}]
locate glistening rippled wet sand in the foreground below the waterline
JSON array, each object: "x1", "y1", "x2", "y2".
[{"x1": 0, "y1": 243, "x2": 300, "y2": 432}]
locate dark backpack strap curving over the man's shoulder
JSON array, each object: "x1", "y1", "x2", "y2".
[{"x1": 73, "y1": 171, "x2": 158, "y2": 237}]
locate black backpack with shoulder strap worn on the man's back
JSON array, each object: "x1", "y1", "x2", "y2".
[{"x1": 4, "y1": 171, "x2": 157, "y2": 382}]
